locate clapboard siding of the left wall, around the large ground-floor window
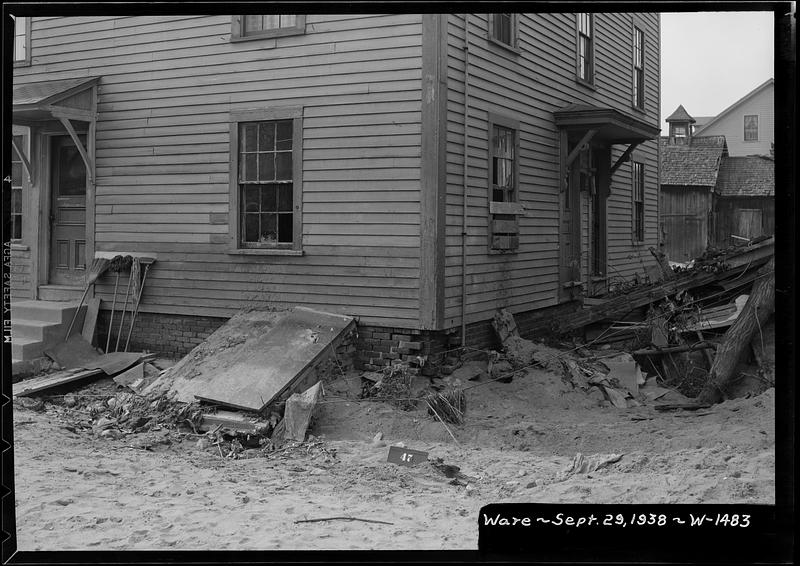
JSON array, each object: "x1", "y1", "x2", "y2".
[{"x1": 15, "y1": 14, "x2": 422, "y2": 327}]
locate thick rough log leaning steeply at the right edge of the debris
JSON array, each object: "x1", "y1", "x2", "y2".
[{"x1": 698, "y1": 256, "x2": 775, "y2": 403}]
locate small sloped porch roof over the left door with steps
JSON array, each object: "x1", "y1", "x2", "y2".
[{"x1": 12, "y1": 77, "x2": 100, "y2": 126}]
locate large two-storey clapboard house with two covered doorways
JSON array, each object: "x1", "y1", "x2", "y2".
[{"x1": 12, "y1": 13, "x2": 660, "y2": 365}]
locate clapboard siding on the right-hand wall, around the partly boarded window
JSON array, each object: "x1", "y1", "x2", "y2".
[{"x1": 445, "y1": 14, "x2": 660, "y2": 326}]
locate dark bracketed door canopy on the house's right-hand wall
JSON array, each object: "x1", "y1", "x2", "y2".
[{"x1": 553, "y1": 104, "x2": 661, "y2": 144}]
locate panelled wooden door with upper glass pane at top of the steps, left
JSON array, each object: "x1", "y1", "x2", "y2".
[{"x1": 49, "y1": 136, "x2": 86, "y2": 287}]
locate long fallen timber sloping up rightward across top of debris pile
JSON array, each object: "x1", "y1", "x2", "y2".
[{"x1": 556, "y1": 238, "x2": 774, "y2": 334}]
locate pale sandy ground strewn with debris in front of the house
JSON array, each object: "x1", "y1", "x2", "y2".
[{"x1": 9, "y1": 364, "x2": 775, "y2": 550}]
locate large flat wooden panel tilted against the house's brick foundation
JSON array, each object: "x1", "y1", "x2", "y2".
[{"x1": 189, "y1": 307, "x2": 355, "y2": 411}]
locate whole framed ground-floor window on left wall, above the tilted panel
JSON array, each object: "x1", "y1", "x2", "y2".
[{"x1": 231, "y1": 107, "x2": 302, "y2": 250}]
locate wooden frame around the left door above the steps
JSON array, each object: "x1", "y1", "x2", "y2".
[{"x1": 31, "y1": 121, "x2": 95, "y2": 298}]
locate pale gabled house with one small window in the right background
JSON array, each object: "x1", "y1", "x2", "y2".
[{"x1": 695, "y1": 79, "x2": 775, "y2": 157}]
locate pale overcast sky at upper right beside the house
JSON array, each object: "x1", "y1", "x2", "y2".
[{"x1": 661, "y1": 12, "x2": 775, "y2": 134}]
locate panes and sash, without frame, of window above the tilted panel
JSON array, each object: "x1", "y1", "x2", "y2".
[{"x1": 239, "y1": 120, "x2": 294, "y2": 248}]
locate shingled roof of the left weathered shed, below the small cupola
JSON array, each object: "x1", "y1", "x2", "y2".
[{"x1": 661, "y1": 136, "x2": 728, "y2": 187}]
